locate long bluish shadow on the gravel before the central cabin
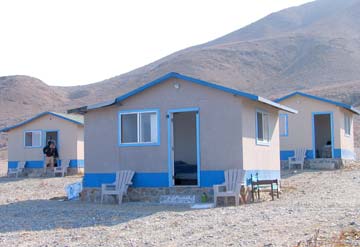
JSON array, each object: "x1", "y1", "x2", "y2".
[{"x1": 0, "y1": 200, "x2": 192, "y2": 233}]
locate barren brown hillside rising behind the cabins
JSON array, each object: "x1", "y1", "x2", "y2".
[{"x1": 0, "y1": 0, "x2": 360, "y2": 149}]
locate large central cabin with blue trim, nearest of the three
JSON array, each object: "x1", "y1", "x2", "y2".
[{"x1": 70, "y1": 73, "x2": 296, "y2": 200}]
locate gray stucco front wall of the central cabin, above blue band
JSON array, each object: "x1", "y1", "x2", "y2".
[{"x1": 85, "y1": 79, "x2": 244, "y2": 173}]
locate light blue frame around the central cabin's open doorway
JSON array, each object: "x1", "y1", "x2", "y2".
[{"x1": 167, "y1": 107, "x2": 201, "y2": 187}]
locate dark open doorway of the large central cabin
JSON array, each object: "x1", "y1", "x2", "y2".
[{"x1": 170, "y1": 111, "x2": 199, "y2": 186}]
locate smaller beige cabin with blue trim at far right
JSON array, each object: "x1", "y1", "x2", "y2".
[{"x1": 276, "y1": 92, "x2": 360, "y2": 166}]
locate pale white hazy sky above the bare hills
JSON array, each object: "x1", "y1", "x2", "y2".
[{"x1": 0, "y1": 0, "x2": 310, "y2": 86}]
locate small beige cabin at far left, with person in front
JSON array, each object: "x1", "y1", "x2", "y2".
[{"x1": 0, "y1": 112, "x2": 84, "y2": 173}]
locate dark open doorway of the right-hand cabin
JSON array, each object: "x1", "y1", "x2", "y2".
[{"x1": 313, "y1": 113, "x2": 334, "y2": 158}]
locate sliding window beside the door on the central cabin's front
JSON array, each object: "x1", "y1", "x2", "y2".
[{"x1": 119, "y1": 111, "x2": 159, "y2": 145}]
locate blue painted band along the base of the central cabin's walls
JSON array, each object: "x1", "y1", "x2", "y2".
[{"x1": 83, "y1": 170, "x2": 280, "y2": 188}]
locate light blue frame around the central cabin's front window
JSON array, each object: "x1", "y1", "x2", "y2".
[{"x1": 118, "y1": 108, "x2": 161, "y2": 147}]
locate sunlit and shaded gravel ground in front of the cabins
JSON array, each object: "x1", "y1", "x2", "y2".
[{"x1": 0, "y1": 168, "x2": 360, "y2": 246}]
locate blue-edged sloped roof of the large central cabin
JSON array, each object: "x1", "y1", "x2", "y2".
[{"x1": 69, "y1": 72, "x2": 297, "y2": 113}]
